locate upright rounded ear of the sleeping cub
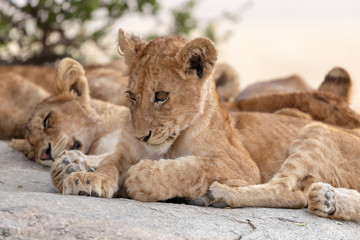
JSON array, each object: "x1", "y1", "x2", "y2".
[{"x1": 55, "y1": 58, "x2": 89, "y2": 99}]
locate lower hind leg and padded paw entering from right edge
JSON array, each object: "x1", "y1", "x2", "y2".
[{"x1": 307, "y1": 182, "x2": 360, "y2": 220}]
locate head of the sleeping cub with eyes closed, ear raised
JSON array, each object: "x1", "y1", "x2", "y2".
[{"x1": 21, "y1": 58, "x2": 98, "y2": 166}]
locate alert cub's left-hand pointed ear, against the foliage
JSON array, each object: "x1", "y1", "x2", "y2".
[{"x1": 118, "y1": 28, "x2": 146, "y2": 66}]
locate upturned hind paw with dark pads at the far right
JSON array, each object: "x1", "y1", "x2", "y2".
[{"x1": 307, "y1": 182, "x2": 336, "y2": 217}]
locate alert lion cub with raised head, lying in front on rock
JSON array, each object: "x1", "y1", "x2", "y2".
[{"x1": 50, "y1": 29, "x2": 360, "y2": 219}]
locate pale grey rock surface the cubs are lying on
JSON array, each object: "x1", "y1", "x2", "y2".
[{"x1": 0, "y1": 142, "x2": 360, "y2": 239}]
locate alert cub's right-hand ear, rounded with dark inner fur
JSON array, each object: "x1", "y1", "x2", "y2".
[{"x1": 178, "y1": 38, "x2": 217, "y2": 79}]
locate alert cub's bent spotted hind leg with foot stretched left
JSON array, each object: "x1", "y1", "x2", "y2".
[{"x1": 200, "y1": 125, "x2": 331, "y2": 208}]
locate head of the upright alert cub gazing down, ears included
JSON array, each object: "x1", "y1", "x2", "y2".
[{"x1": 118, "y1": 29, "x2": 217, "y2": 152}]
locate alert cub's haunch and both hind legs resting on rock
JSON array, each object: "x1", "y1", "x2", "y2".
[{"x1": 210, "y1": 123, "x2": 360, "y2": 220}]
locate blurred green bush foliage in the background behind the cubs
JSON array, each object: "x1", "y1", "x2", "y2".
[{"x1": 0, "y1": 0, "x2": 242, "y2": 64}]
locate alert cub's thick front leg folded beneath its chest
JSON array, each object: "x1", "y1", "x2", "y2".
[{"x1": 124, "y1": 156, "x2": 210, "y2": 201}]
